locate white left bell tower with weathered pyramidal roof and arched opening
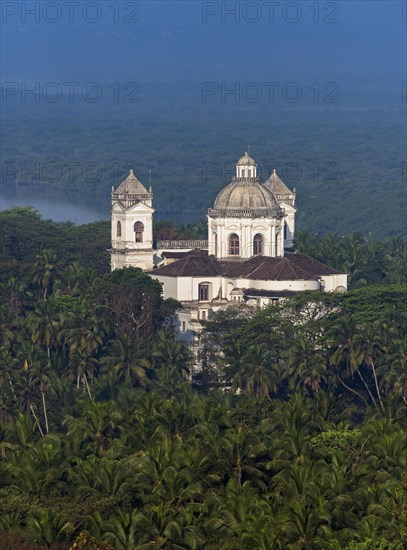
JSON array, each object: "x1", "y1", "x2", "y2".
[{"x1": 110, "y1": 170, "x2": 154, "y2": 271}]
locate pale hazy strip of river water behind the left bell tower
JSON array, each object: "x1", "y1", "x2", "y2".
[{"x1": 0, "y1": 185, "x2": 205, "y2": 225}]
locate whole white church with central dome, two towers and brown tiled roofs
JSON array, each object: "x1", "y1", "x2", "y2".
[{"x1": 110, "y1": 153, "x2": 347, "y2": 343}]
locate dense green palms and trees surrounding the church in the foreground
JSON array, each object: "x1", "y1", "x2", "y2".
[{"x1": 0, "y1": 209, "x2": 407, "y2": 550}]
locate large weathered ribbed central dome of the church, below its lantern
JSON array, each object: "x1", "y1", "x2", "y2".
[{"x1": 213, "y1": 181, "x2": 278, "y2": 211}]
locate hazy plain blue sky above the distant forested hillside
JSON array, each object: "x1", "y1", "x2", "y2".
[{"x1": 1, "y1": 0, "x2": 407, "y2": 90}]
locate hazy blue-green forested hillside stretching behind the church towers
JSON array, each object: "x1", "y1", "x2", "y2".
[{"x1": 1, "y1": 84, "x2": 406, "y2": 238}]
